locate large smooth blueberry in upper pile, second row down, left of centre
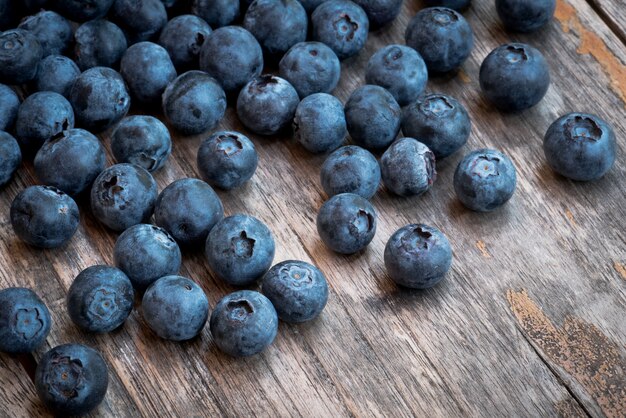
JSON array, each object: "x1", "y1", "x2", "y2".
[{"x1": 200, "y1": 26, "x2": 263, "y2": 92}]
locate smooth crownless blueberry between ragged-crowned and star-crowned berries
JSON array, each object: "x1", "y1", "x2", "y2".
[{"x1": 154, "y1": 178, "x2": 224, "y2": 245}]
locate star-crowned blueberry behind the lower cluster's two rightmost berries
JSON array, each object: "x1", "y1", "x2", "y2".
[{"x1": 205, "y1": 214, "x2": 276, "y2": 286}]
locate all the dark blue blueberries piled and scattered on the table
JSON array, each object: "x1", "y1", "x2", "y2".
[{"x1": 0, "y1": 0, "x2": 615, "y2": 415}]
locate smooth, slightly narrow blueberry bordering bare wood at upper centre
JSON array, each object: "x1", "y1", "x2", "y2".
[{"x1": 293, "y1": 93, "x2": 348, "y2": 153}]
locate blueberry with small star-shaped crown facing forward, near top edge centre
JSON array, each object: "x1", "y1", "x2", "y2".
[{"x1": 311, "y1": 0, "x2": 369, "y2": 60}]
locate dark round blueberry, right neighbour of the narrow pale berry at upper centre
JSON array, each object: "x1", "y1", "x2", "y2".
[{"x1": 345, "y1": 84, "x2": 402, "y2": 150}]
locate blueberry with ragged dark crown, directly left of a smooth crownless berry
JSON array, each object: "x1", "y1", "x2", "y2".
[{"x1": 91, "y1": 164, "x2": 157, "y2": 231}]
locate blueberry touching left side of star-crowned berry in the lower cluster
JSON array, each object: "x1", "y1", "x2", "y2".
[{"x1": 113, "y1": 224, "x2": 181, "y2": 291}]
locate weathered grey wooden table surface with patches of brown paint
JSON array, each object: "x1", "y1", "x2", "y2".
[{"x1": 0, "y1": 0, "x2": 626, "y2": 417}]
